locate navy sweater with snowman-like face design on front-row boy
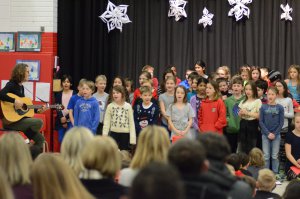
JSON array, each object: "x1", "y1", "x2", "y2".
[{"x1": 133, "y1": 102, "x2": 159, "y2": 135}]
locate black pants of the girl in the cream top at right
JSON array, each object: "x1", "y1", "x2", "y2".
[{"x1": 239, "y1": 119, "x2": 259, "y2": 154}]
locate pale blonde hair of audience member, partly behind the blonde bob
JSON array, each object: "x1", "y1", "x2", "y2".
[{"x1": 61, "y1": 127, "x2": 94, "y2": 176}]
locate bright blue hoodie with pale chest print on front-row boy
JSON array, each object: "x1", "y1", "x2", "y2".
[{"x1": 74, "y1": 97, "x2": 100, "y2": 134}]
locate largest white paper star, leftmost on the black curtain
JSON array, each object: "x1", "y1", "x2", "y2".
[{"x1": 99, "y1": 1, "x2": 131, "y2": 32}]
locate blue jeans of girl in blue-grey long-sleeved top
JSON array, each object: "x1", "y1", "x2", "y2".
[{"x1": 262, "y1": 135, "x2": 281, "y2": 173}]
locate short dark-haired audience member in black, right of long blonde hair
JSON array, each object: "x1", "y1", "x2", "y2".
[{"x1": 168, "y1": 139, "x2": 227, "y2": 199}]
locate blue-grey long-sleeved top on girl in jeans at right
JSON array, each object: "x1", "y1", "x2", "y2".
[{"x1": 259, "y1": 104, "x2": 284, "y2": 136}]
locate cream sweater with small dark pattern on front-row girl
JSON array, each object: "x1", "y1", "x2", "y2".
[{"x1": 103, "y1": 102, "x2": 136, "y2": 144}]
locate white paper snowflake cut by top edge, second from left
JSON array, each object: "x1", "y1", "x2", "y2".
[{"x1": 168, "y1": 0, "x2": 187, "y2": 21}]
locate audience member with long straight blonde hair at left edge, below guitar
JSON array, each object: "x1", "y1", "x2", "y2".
[{"x1": 0, "y1": 132, "x2": 33, "y2": 198}]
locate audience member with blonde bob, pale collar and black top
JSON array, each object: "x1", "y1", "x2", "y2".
[{"x1": 79, "y1": 136, "x2": 126, "y2": 198}]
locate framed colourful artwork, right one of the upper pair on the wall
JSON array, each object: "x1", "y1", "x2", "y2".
[{"x1": 17, "y1": 32, "x2": 41, "y2": 52}]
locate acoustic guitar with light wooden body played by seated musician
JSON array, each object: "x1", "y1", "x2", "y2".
[{"x1": 1, "y1": 93, "x2": 64, "y2": 122}]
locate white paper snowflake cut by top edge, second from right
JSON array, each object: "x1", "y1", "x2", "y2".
[{"x1": 228, "y1": 0, "x2": 252, "y2": 21}]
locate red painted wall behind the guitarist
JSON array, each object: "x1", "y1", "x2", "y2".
[{"x1": 0, "y1": 33, "x2": 57, "y2": 149}]
